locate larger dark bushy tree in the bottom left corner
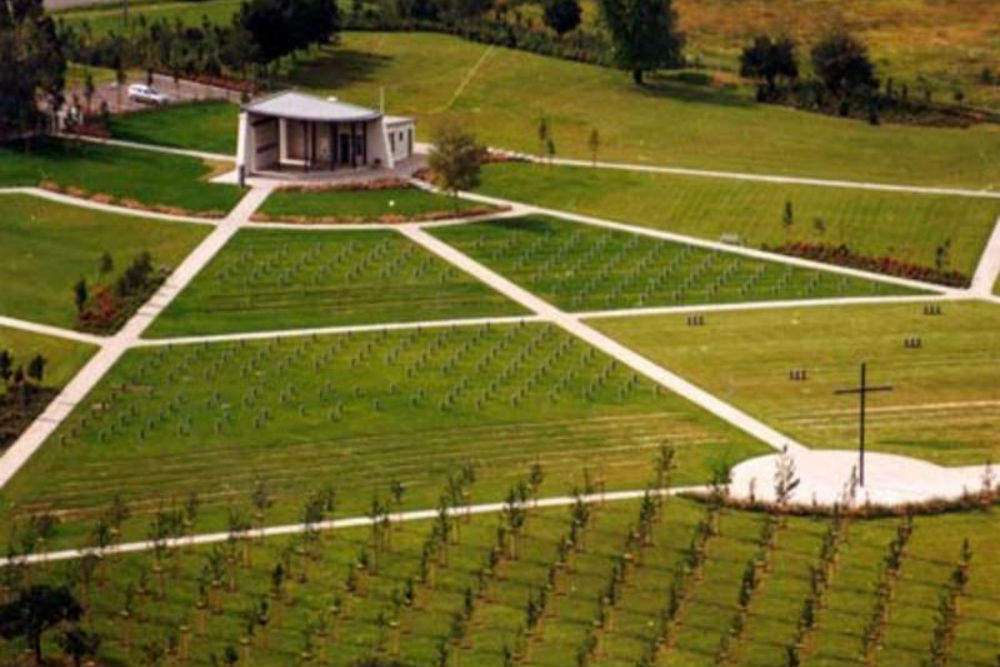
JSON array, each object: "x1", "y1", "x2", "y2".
[{"x1": 0, "y1": 584, "x2": 83, "y2": 665}]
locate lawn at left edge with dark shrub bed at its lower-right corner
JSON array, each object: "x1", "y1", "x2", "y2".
[{"x1": 0, "y1": 195, "x2": 209, "y2": 328}]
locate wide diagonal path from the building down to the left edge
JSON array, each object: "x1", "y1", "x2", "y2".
[{"x1": 0, "y1": 188, "x2": 270, "y2": 488}]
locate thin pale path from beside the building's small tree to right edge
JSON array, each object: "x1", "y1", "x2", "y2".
[{"x1": 491, "y1": 149, "x2": 1000, "y2": 199}]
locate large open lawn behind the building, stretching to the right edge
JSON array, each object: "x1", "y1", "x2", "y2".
[{"x1": 287, "y1": 32, "x2": 1000, "y2": 187}]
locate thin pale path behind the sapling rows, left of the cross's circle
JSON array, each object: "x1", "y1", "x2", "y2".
[{"x1": 0, "y1": 486, "x2": 711, "y2": 567}]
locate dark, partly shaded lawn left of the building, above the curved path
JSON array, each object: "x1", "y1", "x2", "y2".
[{"x1": 0, "y1": 139, "x2": 242, "y2": 216}]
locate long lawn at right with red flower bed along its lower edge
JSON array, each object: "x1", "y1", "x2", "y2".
[{"x1": 479, "y1": 163, "x2": 1000, "y2": 276}]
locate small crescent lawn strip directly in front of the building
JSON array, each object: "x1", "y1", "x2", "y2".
[{"x1": 255, "y1": 187, "x2": 493, "y2": 222}]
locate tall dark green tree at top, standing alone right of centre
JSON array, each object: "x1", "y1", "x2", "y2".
[{"x1": 598, "y1": 0, "x2": 684, "y2": 85}]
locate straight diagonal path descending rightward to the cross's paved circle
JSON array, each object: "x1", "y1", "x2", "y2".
[{"x1": 399, "y1": 225, "x2": 803, "y2": 451}]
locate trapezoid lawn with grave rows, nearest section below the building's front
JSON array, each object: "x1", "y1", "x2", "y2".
[{"x1": 149, "y1": 229, "x2": 525, "y2": 337}]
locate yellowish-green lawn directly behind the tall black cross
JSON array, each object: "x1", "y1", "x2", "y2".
[{"x1": 593, "y1": 302, "x2": 1000, "y2": 465}]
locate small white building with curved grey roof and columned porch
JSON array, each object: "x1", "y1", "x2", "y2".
[{"x1": 236, "y1": 91, "x2": 416, "y2": 180}]
